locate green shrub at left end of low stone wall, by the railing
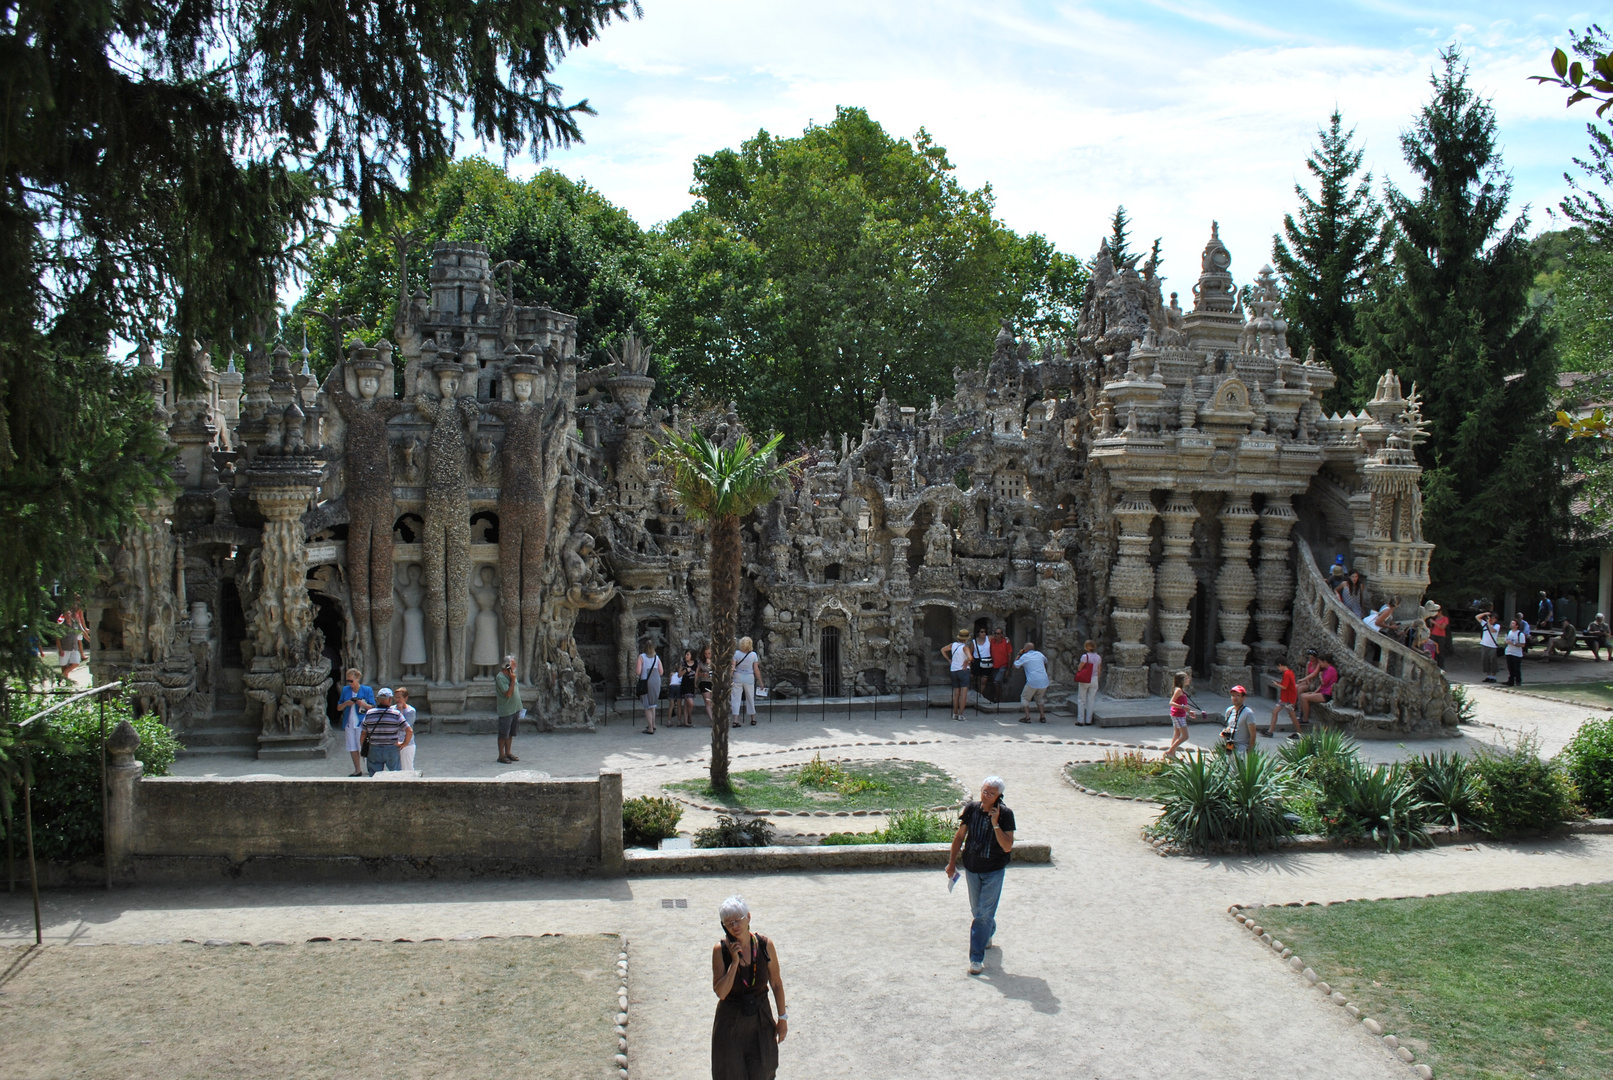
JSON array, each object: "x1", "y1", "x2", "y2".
[{"x1": 0, "y1": 698, "x2": 184, "y2": 861}]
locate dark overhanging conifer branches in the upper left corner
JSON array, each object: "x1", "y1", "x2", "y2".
[{"x1": 0, "y1": 0, "x2": 637, "y2": 686}]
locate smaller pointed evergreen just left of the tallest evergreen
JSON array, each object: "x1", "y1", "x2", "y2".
[{"x1": 1271, "y1": 110, "x2": 1389, "y2": 409}]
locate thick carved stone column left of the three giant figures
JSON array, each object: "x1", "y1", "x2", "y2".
[{"x1": 244, "y1": 453, "x2": 331, "y2": 758}]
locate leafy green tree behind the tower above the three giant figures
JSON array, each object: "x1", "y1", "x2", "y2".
[{"x1": 300, "y1": 158, "x2": 653, "y2": 377}]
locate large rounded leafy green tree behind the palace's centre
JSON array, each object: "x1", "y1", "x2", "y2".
[{"x1": 652, "y1": 108, "x2": 1086, "y2": 438}]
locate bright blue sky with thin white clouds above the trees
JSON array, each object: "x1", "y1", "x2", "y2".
[{"x1": 487, "y1": 0, "x2": 1595, "y2": 289}]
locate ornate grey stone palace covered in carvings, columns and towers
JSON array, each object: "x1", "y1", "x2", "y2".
[{"x1": 89, "y1": 231, "x2": 1455, "y2": 756}]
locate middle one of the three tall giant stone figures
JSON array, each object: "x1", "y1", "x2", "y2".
[{"x1": 415, "y1": 361, "x2": 479, "y2": 683}]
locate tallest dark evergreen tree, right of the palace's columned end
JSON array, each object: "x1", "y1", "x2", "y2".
[{"x1": 1355, "y1": 48, "x2": 1574, "y2": 603}]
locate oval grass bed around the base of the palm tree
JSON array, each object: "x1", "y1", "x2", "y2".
[{"x1": 666, "y1": 756, "x2": 963, "y2": 811}]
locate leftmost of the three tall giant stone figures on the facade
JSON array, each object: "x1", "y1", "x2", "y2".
[{"x1": 324, "y1": 340, "x2": 405, "y2": 679}]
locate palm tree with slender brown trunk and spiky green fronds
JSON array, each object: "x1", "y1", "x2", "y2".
[{"x1": 656, "y1": 430, "x2": 792, "y2": 791}]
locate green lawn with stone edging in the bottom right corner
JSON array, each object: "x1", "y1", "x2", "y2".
[{"x1": 1260, "y1": 885, "x2": 1613, "y2": 1080}]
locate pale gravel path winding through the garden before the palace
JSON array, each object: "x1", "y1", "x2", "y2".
[{"x1": 12, "y1": 690, "x2": 1613, "y2": 1080}]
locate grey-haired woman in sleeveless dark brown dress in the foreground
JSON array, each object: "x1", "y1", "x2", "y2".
[{"x1": 711, "y1": 895, "x2": 790, "y2": 1080}]
